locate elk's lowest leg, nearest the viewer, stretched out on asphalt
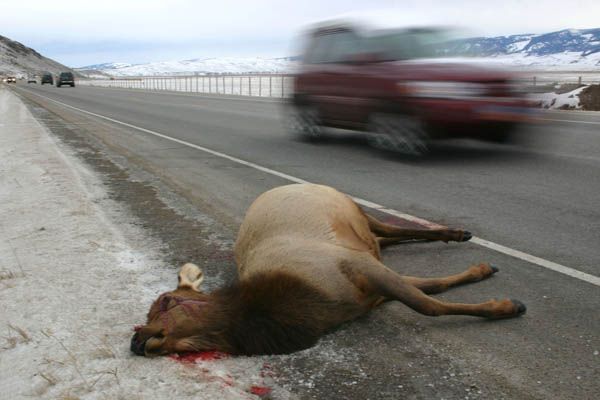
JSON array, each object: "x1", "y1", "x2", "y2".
[{"x1": 341, "y1": 256, "x2": 526, "y2": 319}]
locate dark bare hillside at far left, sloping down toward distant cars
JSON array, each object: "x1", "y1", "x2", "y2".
[{"x1": 0, "y1": 36, "x2": 71, "y2": 75}]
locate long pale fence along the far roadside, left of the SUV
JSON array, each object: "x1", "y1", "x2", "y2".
[{"x1": 78, "y1": 74, "x2": 293, "y2": 97}]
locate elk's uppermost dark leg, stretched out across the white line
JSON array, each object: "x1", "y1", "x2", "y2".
[{"x1": 365, "y1": 214, "x2": 473, "y2": 242}]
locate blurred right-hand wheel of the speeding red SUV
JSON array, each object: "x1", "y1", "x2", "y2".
[{"x1": 369, "y1": 113, "x2": 429, "y2": 156}]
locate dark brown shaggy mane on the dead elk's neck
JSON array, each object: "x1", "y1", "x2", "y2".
[{"x1": 197, "y1": 272, "x2": 350, "y2": 355}]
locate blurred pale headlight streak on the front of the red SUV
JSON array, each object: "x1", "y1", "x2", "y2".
[{"x1": 397, "y1": 81, "x2": 486, "y2": 99}]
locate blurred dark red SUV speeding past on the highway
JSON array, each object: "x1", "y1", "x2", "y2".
[{"x1": 288, "y1": 24, "x2": 532, "y2": 155}]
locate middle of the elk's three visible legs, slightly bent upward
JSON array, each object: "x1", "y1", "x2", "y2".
[{"x1": 402, "y1": 263, "x2": 498, "y2": 294}]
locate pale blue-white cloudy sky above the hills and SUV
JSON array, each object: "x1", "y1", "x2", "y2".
[{"x1": 0, "y1": 0, "x2": 600, "y2": 67}]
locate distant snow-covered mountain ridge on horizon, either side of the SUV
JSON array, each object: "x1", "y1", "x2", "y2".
[{"x1": 78, "y1": 28, "x2": 600, "y2": 76}]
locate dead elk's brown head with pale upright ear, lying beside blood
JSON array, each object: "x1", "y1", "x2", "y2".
[{"x1": 130, "y1": 263, "x2": 216, "y2": 357}]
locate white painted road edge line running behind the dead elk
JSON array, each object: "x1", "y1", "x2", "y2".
[{"x1": 18, "y1": 91, "x2": 600, "y2": 286}]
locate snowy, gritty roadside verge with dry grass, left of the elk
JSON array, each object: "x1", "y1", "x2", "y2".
[{"x1": 0, "y1": 87, "x2": 288, "y2": 400}]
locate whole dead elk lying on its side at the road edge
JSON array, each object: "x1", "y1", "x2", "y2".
[{"x1": 131, "y1": 184, "x2": 525, "y2": 356}]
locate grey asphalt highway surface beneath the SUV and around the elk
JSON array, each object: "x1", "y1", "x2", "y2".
[{"x1": 10, "y1": 85, "x2": 600, "y2": 399}]
